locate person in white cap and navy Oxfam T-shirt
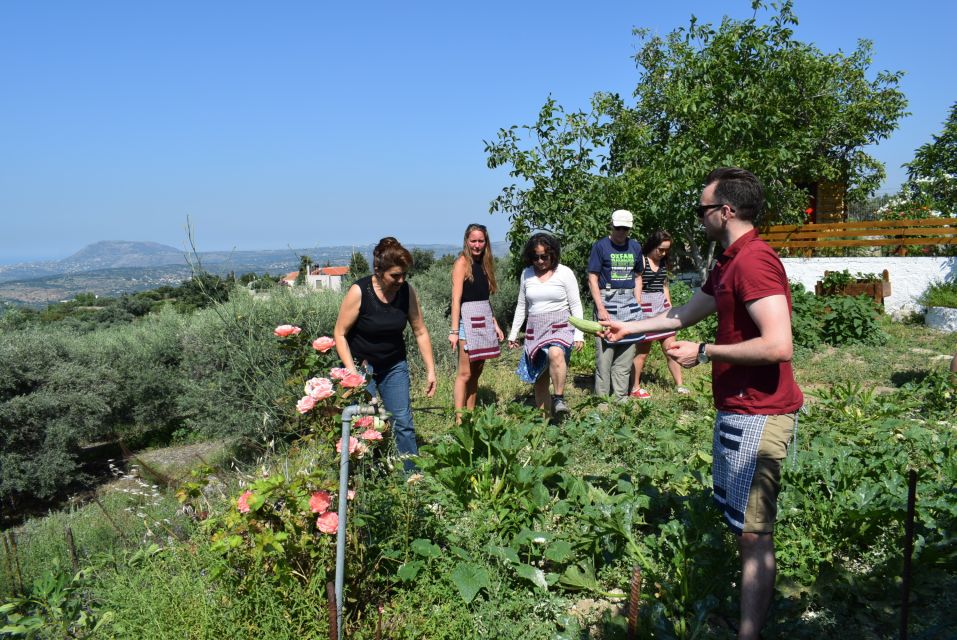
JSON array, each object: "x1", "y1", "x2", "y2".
[{"x1": 588, "y1": 209, "x2": 644, "y2": 399}]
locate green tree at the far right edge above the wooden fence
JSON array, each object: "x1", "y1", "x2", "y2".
[{"x1": 904, "y1": 102, "x2": 957, "y2": 215}]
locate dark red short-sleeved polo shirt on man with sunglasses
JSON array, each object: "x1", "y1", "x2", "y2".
[{"x1": 701, "y1": 229, "x2": 804, "y2": 415}]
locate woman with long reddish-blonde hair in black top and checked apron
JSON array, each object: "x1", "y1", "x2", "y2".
[{"x1": 449, "y1": 224, "x2": 505, "y2": 421}]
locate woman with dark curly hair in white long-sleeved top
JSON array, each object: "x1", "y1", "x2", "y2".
[{"x1": 508, "y1": 233, "x2": 584, "y2": 418}]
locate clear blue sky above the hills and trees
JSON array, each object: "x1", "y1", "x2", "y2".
[{"x1": 0, "y1": 0, "x2": 957, "y2": 262}]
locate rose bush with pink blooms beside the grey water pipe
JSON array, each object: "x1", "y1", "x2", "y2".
[{"x1": 204, "y1": 325, "x2": 387, "y2": 581}]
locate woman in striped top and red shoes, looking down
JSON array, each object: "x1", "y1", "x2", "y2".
[{"x1": 631, "y1": 229, "x2": 689, "y2": 400}]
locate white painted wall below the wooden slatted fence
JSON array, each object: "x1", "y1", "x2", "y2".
[{"x1": 781, "y1": 257, "x2": 957, "y2": 313}]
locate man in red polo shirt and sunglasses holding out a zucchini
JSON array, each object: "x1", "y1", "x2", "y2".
[{"x1": 602, "y1": 168, "x2": 804, "y2": 640}]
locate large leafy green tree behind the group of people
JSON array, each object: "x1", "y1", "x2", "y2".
[{"x1": 486, "y1": 1, "x2": 906, "y2": 269}]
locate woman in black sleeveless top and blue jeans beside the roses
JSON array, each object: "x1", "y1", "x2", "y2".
[{"x1": 333, "y1": 237, "x2": 435, "y2": 471}]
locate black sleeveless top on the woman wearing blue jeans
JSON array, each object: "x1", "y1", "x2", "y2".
[{"x1": 346, "y1": 276, "x2": 409, "y2": 369}]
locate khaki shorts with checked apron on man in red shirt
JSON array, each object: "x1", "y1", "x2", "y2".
[{"x1": 711, "y1": 411, "x2": 797, "y2": 535}]
